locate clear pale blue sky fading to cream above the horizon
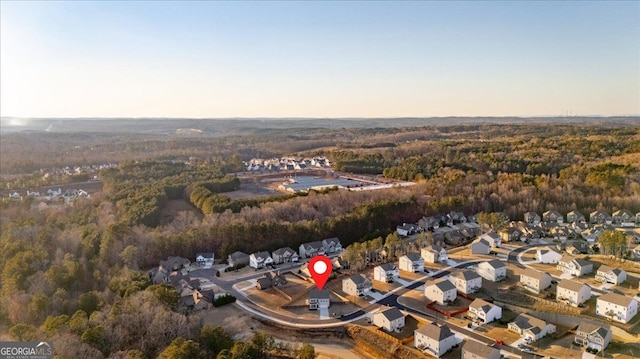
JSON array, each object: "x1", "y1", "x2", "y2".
[{"x1": 0, "y1": 0, "x2": 640, "y2": 118}]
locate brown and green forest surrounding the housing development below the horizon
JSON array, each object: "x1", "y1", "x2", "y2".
[{"x1": 0, "y1": 122, "x2": 640, "y2": 358}]
